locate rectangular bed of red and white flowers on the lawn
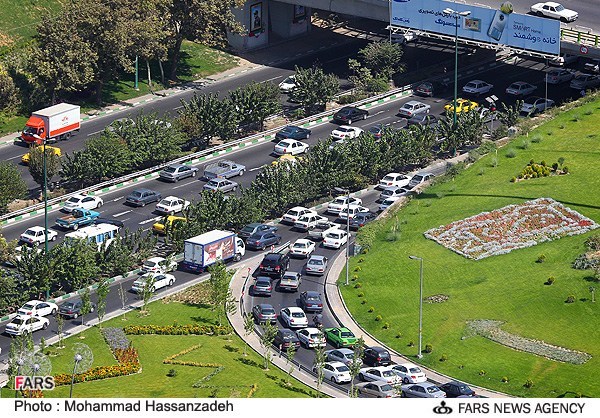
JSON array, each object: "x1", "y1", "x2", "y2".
[{"x1": 424, "y1": 197, "x2": 598, "y2": 260}]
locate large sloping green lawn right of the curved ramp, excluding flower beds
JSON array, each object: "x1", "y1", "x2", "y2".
[{"x1": 340, "y1": 101, "x2": 600, "y2": 397}]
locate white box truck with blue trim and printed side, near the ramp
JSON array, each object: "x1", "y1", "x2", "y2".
[{"x1": 182, "y1": 229, "x2": 246, "y2": 273}]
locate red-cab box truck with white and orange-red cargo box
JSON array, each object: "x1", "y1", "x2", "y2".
[{"x1": 19, "y1": 103, "x2": 81, "y2": 145}]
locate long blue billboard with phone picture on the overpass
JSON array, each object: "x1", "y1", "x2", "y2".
[{"x1": 390, "y1": 0, "x2": 560, "y2": 55}]
